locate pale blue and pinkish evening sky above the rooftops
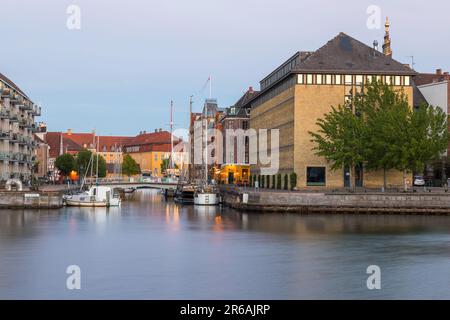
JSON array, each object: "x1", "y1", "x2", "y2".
[{"x1": 0, "y1": 0, "x2": 450, "y2": 135}]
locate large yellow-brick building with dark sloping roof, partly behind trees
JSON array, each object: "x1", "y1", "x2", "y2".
[{"x1": 246, "y1": 29, "x2": 416, "y2": 188}]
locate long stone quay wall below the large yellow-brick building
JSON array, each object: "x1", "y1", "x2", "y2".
[{"x1": 221, "y1": 188, "x2": 450, "y2": 215}]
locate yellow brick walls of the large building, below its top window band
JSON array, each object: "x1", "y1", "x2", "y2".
[{"x1": 250, "y1": 79, "x2": 413, "y2": 189}]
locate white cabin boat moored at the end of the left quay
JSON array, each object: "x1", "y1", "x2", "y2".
[{"x1": 64, "y1": 186, "x2": 121, "y2": 207}]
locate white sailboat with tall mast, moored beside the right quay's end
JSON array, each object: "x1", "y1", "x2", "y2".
[{"x1": 194, "y1": 98, "x2": 220, "y2": 206}]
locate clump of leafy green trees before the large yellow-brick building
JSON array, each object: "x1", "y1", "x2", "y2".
[{"x1": 310, "y1": 82, "x2": 449, "y2": 188}]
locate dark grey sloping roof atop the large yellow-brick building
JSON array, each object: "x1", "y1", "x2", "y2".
[{"x1": 292, "y1": 32, "x2": 416, "y2": 75}]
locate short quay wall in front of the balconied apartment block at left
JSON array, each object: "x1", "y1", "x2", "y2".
[{"x1": 0, "y1": 191, "x2": 63, "y2": 209}]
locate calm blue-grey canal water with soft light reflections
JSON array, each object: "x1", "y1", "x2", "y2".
[{"x1": 0, "y1": 190, "x2": 450, "y2": 299}]
